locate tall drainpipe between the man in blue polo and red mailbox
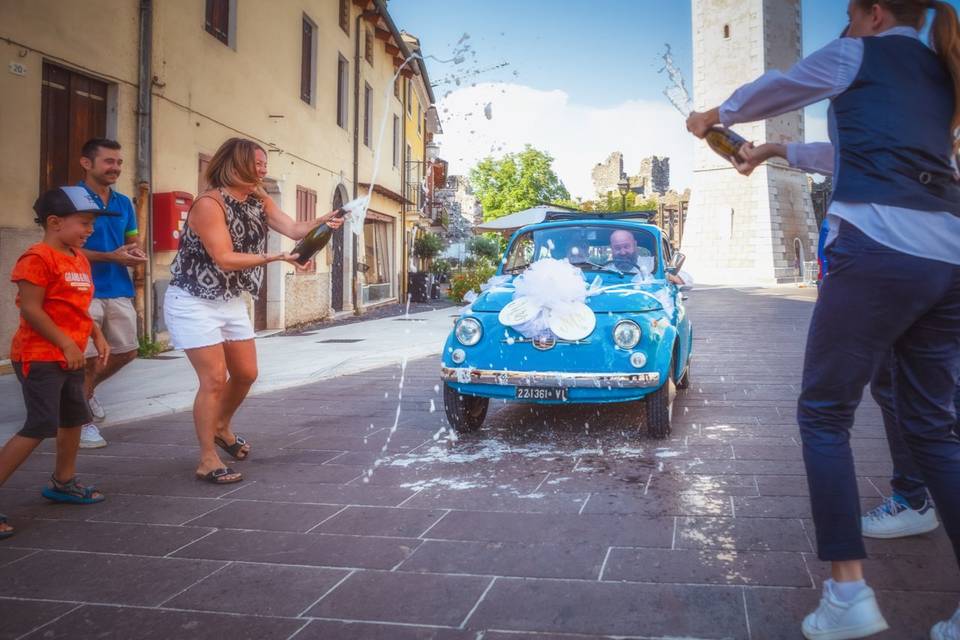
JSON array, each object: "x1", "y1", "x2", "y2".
[{"x1": 137, "y1": 0, "x2": 154, "y2": 341}]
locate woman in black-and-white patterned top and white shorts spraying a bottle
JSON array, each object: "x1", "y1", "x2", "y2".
[{"x1": 163, "y1": 138, "x2": 342, "y2": 484}]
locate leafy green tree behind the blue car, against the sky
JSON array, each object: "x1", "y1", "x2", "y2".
[{"x1": 470, "y1": 145, "x2": 570, "y2": 221}]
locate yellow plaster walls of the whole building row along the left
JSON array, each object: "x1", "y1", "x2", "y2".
[{"x1": 0, "y1": 0, "x2": 422, "y2": 358}]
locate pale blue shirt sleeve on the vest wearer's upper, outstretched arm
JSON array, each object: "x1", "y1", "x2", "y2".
[{"x1": 720, "y1": 38, "x2": 863, "y2": 127}]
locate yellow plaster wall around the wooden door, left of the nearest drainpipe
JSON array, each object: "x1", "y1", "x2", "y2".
[{"x1": 0, "y1": 0, "x2": 139, "y2": 359}]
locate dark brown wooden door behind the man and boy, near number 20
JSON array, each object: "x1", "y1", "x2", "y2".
[{"x1": 40, "y1": 62, "x2": 107, "y2": 192}]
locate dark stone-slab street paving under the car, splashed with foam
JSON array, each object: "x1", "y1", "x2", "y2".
[{"x1": 0, "y1": 289, "x2": 960, "y2": 640}]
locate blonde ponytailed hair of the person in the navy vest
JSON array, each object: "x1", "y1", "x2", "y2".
[{"x1": 857, "y1": 0, "x2": 960, "y2": 153}]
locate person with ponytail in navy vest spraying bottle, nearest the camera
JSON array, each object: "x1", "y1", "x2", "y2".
[{"x1": 687, "y1": 0, "x2": 960, "y2": 640}]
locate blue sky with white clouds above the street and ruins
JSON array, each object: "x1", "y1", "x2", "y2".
[{"x1": 389, "y1": 0, "x2": 960, "y2": 196}]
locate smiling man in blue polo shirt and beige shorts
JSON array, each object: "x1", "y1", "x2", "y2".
[{"x1": 80, "y1": 138, "x2": 147, "y2": 449}]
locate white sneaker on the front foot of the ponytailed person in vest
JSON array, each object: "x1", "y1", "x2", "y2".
[{"x1": 800, "y1": 580, "x2": 888, "y2": 640}]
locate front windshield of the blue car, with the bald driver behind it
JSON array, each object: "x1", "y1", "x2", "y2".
[{"x1": 503, "y1": 225, "x2": 657, "y2": 275}]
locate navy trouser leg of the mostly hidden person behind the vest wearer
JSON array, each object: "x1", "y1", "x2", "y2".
[{"x1": 870, "y1": 351, "x2": 960, "y2": 509}]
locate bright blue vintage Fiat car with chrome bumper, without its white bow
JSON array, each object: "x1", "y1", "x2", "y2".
[{"x1": 441, "y1": 212, "x2": 693, "y2": 438}]
